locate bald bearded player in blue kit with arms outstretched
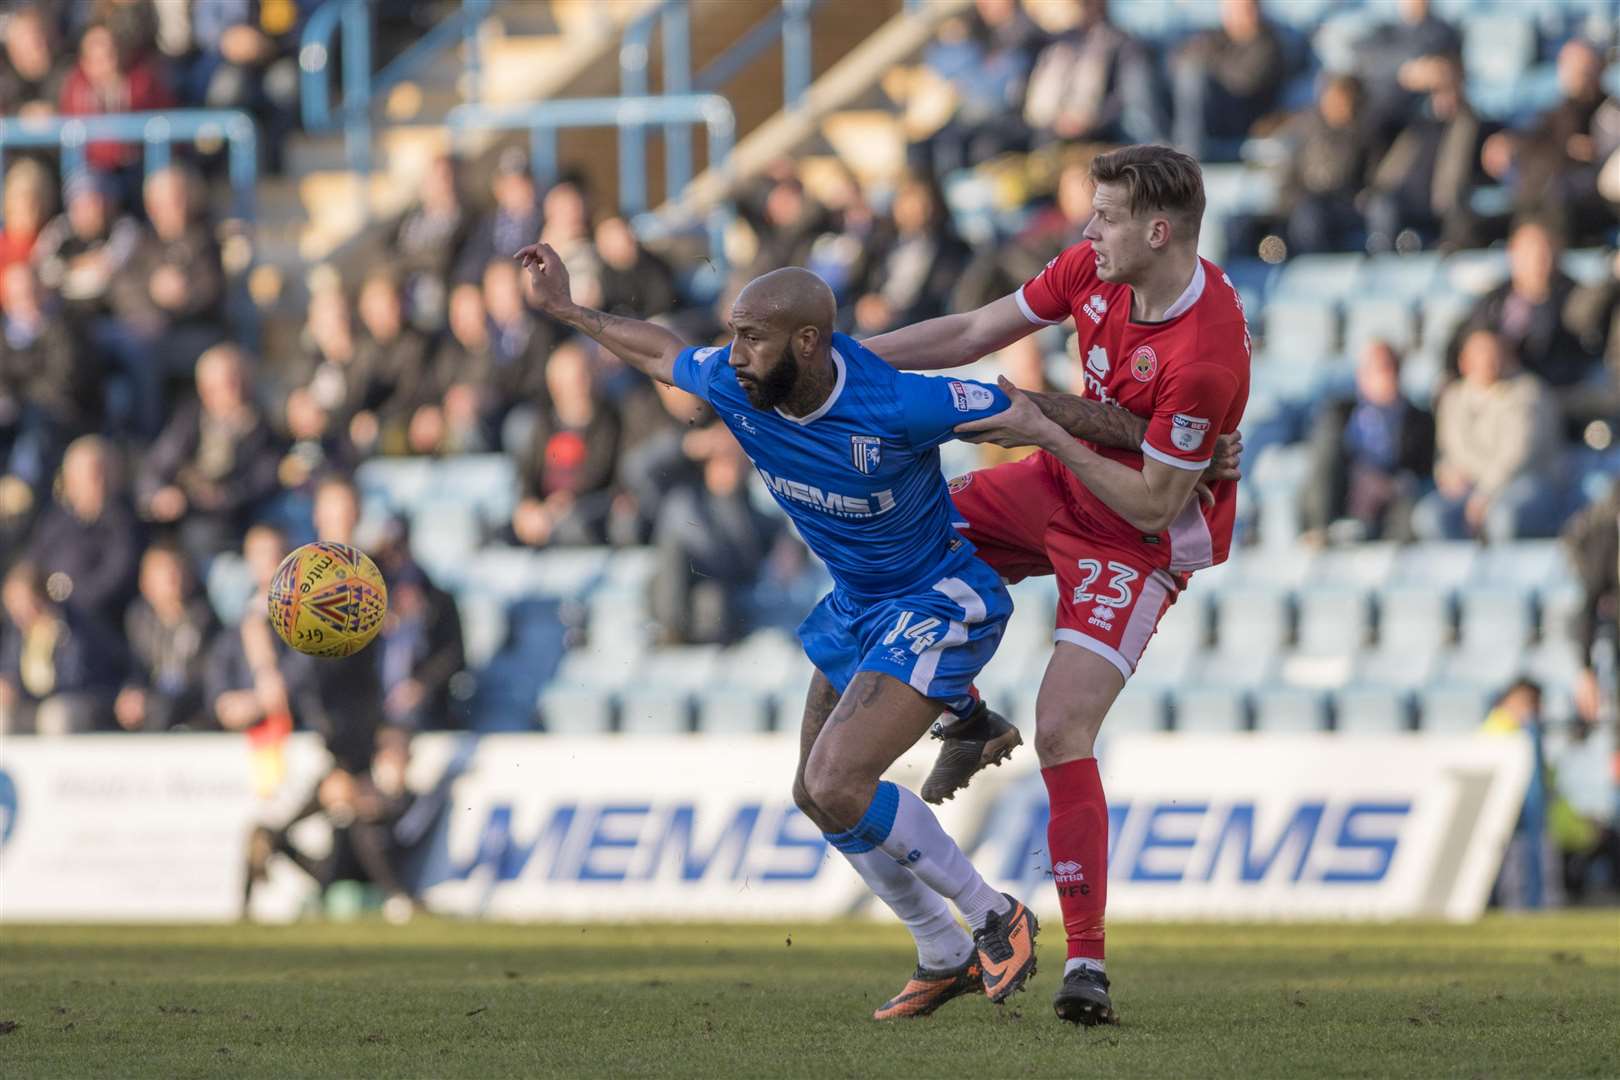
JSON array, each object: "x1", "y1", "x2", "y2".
[{"x1": 517, "y1": 243, "x2": 1040, "y2": 1020}]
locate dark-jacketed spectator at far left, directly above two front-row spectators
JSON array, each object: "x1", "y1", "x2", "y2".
[{"x1": 31, "y1": 436, "x2": 141, "y2": 630}]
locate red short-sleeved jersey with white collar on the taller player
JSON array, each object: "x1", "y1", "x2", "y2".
[{"x1": 1017, "y1": 240, "x2": 1249, "y2": 573}]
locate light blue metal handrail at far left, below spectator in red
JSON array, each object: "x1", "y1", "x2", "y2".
[{"x1": 0, "y1": 108, "x2": 259, "y2": 220}]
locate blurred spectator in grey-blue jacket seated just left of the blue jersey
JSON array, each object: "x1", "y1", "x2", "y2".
[{"x1": 651, "y1": 426, "x2": 782, "y2": 644}]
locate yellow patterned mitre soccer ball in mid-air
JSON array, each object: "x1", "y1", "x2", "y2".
[{"x1": 269, "y1": 541, "x2": 389, "y2": 657}]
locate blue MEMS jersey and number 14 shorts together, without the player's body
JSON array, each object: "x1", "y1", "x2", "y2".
[{"x1": 674, "y1": 334, "x2": 1013, "y2": 716}]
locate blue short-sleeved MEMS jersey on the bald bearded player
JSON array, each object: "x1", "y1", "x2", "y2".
[{"x1": 676, "y1": 334, "x2": 1008, "y2": 599}]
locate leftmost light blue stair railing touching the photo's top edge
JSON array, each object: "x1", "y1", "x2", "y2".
[{"x1": 298, "y1": 0, "x2": 492, "y2": 173}]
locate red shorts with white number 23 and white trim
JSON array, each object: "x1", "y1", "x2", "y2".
[{"x1": 951, "y1": 453, "x2": 1186, "y2": 678}]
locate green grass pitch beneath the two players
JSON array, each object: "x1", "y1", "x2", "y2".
[{"x1": 0, "y1": 912, "x2": 1620, "y2": 1080}]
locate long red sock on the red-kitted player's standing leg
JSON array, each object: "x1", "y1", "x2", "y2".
[{"x1": 1040, "y1": 758, "x2": 1108, "y2": 960}]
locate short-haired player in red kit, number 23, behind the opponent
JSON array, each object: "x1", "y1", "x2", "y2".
[{"x1": 865, "y1": 146, "x2": 1249, "y2": 1025}]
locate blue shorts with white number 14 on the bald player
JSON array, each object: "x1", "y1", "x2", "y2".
[{"x1": 799, "y1": 559, "x2": 1013, "y2": 714}]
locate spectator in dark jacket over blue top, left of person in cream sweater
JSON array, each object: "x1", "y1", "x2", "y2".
[{"x1": 1304, "y1": 340, "x2": 1434, "y2": 542}]
